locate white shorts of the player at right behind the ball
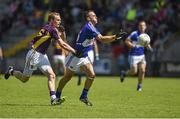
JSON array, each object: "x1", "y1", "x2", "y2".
[{"x1": 128, "y1": 55, "x2": 146, "y2": 67}]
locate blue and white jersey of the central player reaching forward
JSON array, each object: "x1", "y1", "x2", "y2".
[{"x1": 75, "y1": 22, "x2": 100, "y2": 57}]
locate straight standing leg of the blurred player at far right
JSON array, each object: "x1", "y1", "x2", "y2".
[{"x1": 137, "y1": 63, "x2": 146, "y2": 91}]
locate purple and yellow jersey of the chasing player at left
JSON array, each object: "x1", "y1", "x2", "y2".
[{"x1": 31, "y1": 24, "x2": 59, "y2": 54}]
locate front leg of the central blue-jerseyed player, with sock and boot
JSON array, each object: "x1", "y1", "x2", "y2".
[{"x1": 80, "y1": 63, "x2": 95, "y2": 106}]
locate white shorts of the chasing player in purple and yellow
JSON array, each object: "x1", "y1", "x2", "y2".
[{"x1": 23, "y1": 49, "x2": 51, "y2": 76}]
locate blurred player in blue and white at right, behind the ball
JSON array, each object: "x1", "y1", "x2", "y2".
[{"x1": 121, "y1": 21, "x2": 152, "y2": 91}]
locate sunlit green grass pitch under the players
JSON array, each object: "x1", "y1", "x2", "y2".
[{"x1": 0, "y1": 76, "x2": 180, "y2": 118}]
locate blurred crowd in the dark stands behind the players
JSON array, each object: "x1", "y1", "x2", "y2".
[{"x1": 0, "y1": 0, "x2": 180, "y2": 76}]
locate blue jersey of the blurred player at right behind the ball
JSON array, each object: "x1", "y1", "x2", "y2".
[{"x1": 128, "y1": 31, "x2": 144, "y2": 56}]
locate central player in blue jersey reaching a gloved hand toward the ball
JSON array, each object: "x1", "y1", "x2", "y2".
[{"x1": 56, "y1": 10, "x2": 126, "y2": 106}]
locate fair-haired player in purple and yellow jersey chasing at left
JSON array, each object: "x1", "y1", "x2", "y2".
[{"x1": 4, "y1": 12, "x2": 76, "y2": 105}]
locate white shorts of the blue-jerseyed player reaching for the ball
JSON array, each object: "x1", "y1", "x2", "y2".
[{"x1": 65, "y1": 51, "x2": 94, "y2": 71}]
